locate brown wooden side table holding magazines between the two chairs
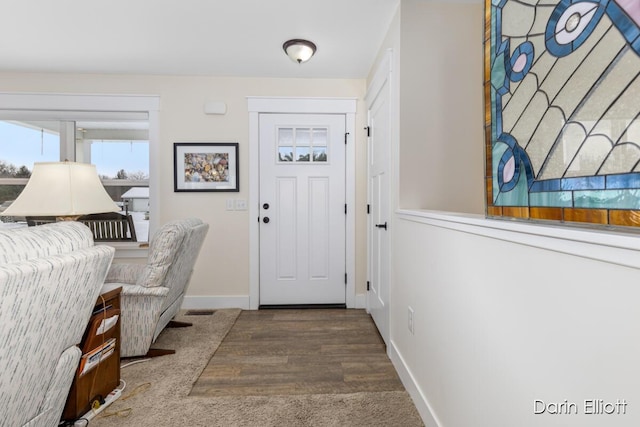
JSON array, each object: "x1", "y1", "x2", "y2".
[{"x1": 62, "y1": 287, "x2": 122, "y2": 421}]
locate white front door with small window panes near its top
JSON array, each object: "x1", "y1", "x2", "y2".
[{"x1": 259, "y1": 114, "x2": 346, "y2": 306}]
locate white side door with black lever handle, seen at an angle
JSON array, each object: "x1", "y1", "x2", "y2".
[{"x1": 367, "y1": 62, "x2": 391, "y2": 344}]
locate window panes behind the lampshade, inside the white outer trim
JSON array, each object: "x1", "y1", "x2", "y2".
[{"x1": 0, "y1": 120, "x2": 149, "y2": 241}]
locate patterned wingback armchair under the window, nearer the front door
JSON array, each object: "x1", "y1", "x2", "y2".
[{"x1": 103, "y1": 218, "x2": 209, "y2": 357}]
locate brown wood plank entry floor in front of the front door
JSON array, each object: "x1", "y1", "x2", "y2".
[{"x1": 191, "y1": 309, "x2": 404, "y2": 396}]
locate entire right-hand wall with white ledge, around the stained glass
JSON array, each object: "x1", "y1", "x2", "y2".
[{"x1": 370, "y1": 0, "x2": 640, "y2": 427}]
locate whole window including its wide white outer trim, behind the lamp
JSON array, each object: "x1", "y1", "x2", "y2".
[{"x1": 0, "y1": 94, "x2": 157, "y2": 241}]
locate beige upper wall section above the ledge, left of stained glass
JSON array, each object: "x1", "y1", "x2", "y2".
[{"x1": 399, "y1": 0, "x2": 484, "y2": 214}]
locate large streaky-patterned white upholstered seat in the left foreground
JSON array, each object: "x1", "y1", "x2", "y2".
[{"x1": 0, "y1": 222, "x2": 114, "y2": 427}]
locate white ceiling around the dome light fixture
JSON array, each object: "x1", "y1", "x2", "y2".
[{"x1": 0, "y1": 0, "x2": 399, "y2": 78}]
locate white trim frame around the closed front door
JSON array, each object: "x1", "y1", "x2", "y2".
[{"x1": 247, "y1": 96, "x2": 357, "y2": 310}]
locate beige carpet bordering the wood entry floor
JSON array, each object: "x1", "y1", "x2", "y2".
[{"x1": 90, "y1": 309, "x2": 423, "y2": 427}]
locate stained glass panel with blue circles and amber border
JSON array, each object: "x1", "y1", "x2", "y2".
[{"x1": 485, "y1": 0, "x2": 640, "y2": 226}]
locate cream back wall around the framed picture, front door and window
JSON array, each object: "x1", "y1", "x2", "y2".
[{"x1": 0, "y1": 73, "x2": 366, "y2": 307}]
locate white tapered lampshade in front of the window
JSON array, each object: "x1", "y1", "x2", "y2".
[{"x1": 2, "y1": 162, "x2": 120, "y2": 217}]
